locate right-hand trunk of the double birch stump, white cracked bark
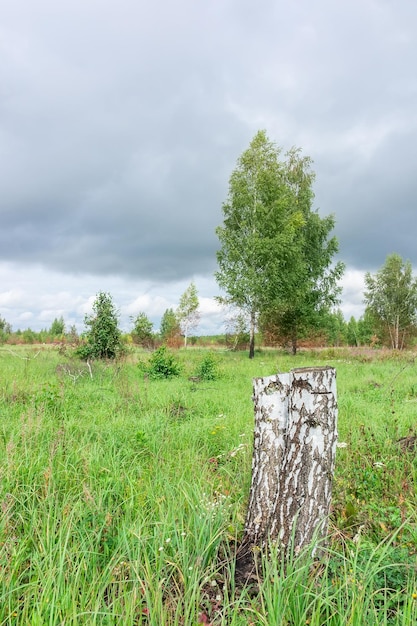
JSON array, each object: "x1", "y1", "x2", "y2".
[{"x1": 270, "y1": 367, "x2": 337, "y2": 553}]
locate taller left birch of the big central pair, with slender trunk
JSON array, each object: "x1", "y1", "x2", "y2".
[{"x1": 215, "y1": 131, "x2": 300, "y2": 358}]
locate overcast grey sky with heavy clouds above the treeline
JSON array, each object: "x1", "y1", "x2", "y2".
[{"x1": 0, "y1": 0, "x2": 417, "y2": 333}]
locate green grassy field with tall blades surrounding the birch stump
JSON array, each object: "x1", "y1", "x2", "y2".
[{"x1": 0, "y1": 346, "x2": 417, "y2": 626}]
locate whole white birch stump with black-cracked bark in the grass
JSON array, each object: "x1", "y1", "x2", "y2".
[{"x1": 237, "y1": 367, "x2": 337, "y2": 573}]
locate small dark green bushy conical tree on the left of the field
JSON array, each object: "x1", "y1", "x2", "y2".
[{"x1": 77, "y1": 292, "x2": 123, "y2": 359}]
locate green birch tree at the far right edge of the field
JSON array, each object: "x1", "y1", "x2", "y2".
[{"x1": 365, "y1": 254, "x2": 417, "y2": 350}]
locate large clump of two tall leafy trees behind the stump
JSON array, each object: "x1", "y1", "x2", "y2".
[{"x1": 216, "y1": 131, "x2": 344, "y2": 358}]
